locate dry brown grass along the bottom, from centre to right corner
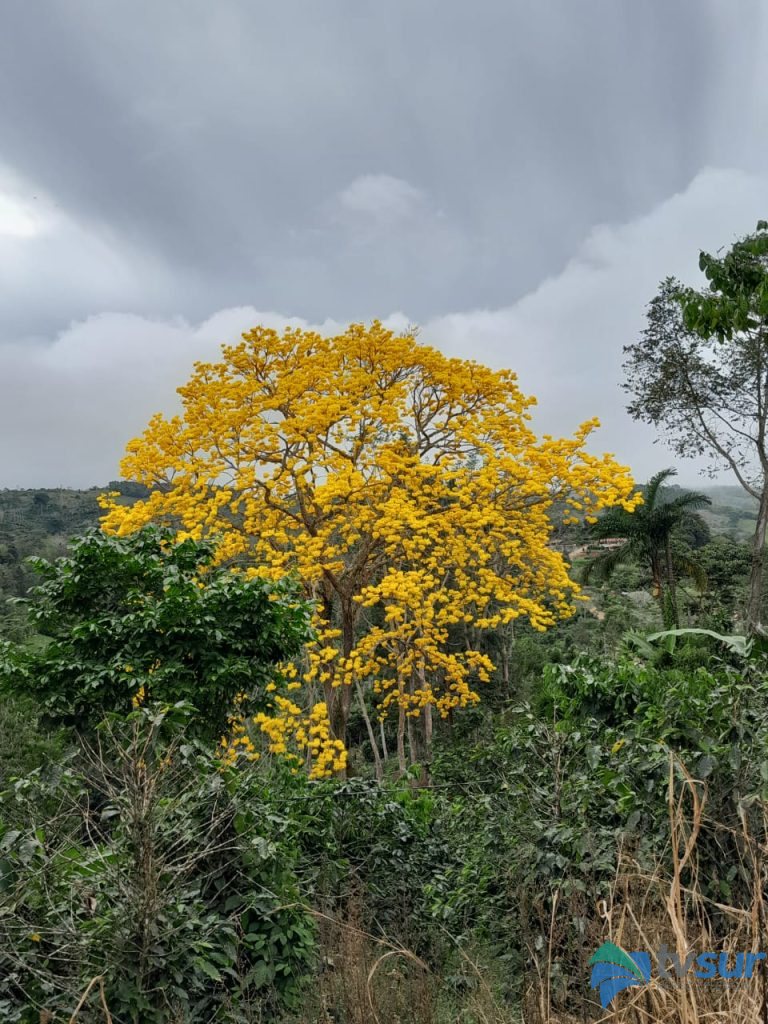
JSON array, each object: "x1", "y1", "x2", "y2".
[{"x1": 295, "y1": 760, "x2": 768, "y2": 1024}]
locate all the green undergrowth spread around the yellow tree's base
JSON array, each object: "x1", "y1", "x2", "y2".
[{"x1": 0, "y1": 474, "x2": 768, "y2": 1024}]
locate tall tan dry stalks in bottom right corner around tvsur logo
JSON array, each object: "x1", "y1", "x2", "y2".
[{"x1": 536, "y1": 763, "x2": 768, "y2": 1024}]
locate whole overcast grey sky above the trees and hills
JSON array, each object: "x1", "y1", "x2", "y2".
[{"x1": 0, "y1": 0, "x2": 768, "y2": 486}]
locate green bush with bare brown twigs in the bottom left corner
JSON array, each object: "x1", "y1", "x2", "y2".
[{"x1": 0, "y1": 705, "x2": 314, "y2": 1024}]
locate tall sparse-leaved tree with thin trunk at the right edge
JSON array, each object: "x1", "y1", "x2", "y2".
[{"x1": 625, "y1": 221, "x2": 768, "y2": 633}]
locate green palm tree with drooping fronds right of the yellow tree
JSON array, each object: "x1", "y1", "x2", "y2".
[{"x1": 582, "y1": 469, "x2": 712, "y2": 629}]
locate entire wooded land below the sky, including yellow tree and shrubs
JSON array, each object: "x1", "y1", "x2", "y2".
[{"x1": 0, "y1": 221, "x2": 768, "y2": 1024}]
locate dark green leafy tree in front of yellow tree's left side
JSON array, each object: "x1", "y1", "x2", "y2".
[{"x1": 0, "y1": 527, "x2": 309, "y2": 739}]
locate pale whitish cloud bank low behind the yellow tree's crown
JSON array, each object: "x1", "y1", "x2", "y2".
[{"x1": 0, "y1": 170, "x2": 768, "y2": 486}]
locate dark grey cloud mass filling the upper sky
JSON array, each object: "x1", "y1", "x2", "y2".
[{"x1": 0, "y1": 0, "x2": 760, "y2": 317}]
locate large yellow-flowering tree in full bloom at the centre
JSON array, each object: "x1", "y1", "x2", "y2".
[{"x1": 103, "y1": 322, "x2": 639, "y2": 770}]
